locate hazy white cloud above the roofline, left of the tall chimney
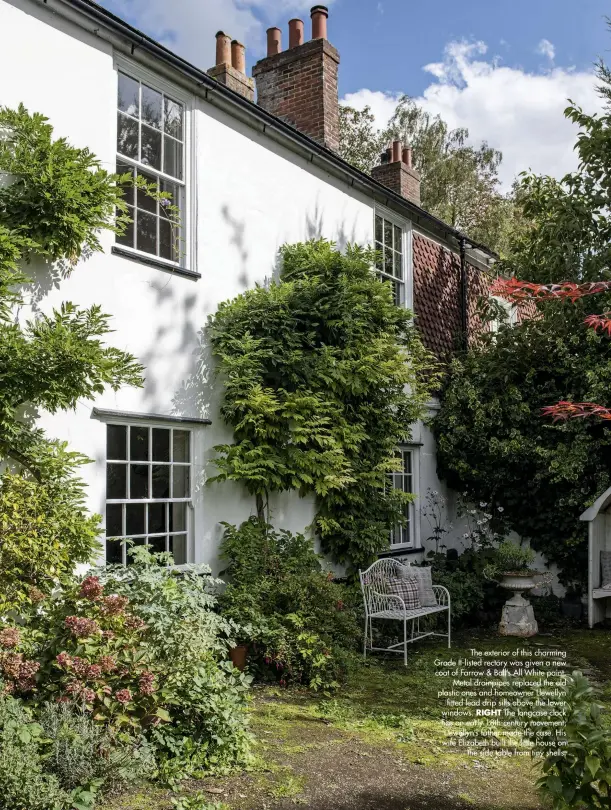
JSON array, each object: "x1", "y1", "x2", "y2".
[{"x1": 103, "y1": 0, "x2": 333, "y2": 69}]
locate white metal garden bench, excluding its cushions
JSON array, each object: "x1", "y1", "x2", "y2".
[{"x1": 359, "y1": 557, "x2": 451, "y2": 666}]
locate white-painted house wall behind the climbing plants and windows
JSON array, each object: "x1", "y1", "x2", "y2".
[{"x1": 0, "y1": 0, "x2": 488, "y2": 571}]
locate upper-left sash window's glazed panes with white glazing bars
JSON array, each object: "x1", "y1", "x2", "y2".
[{"x1": 117, "y1": 71, "x2": 185, "y2": 264}]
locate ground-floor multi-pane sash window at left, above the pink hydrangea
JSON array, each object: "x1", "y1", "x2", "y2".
[{"x1": 106, "y1": 424, "x2": 192, "y2": 565}]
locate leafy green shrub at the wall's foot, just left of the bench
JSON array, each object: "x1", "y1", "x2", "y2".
[{"x1": 220, "y1": 518, "x2": 360, "y2": 689}]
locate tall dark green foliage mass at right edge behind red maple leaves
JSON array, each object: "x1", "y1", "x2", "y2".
[{"x1": 434, "y1": 52, "x2": 611, "y2": 580}]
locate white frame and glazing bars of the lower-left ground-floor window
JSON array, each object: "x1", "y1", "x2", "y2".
[{"x1": 102, "y1": 416, "x2": 195, "y2": 568}]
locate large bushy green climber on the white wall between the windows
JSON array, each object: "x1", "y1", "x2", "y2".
[{"x1": 209, "y1": 240, "x2": 436, "y2": 566}]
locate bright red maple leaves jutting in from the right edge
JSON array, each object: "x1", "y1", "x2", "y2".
[{"x1": 490, "y1": 278, "x2": 611, "y2": 422}]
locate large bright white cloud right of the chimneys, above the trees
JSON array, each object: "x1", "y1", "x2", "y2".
[{"x1": 343, "y1": 42, "x2": 601, "y2": 189}]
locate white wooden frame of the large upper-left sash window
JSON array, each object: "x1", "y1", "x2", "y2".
[{"x1": 113, "y1": 54, "x2": 197, "y2": 271}]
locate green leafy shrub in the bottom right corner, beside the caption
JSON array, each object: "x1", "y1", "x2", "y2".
[{"x1": 538, "y1": 672, "x2": 611, "y2": 810}]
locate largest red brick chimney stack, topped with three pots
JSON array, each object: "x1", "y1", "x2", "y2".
[{"x1": 253, "y1": 6, "x2": 339, "y2": 151}]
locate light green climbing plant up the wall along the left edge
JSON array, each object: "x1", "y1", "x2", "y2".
[{"x1": 0, "y1": 106, "x2": 172, "y2": 614}]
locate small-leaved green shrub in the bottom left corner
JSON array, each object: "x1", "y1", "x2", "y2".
[{"x1": 0, "y1": 695, "x2": 72, "y2": 810}]
